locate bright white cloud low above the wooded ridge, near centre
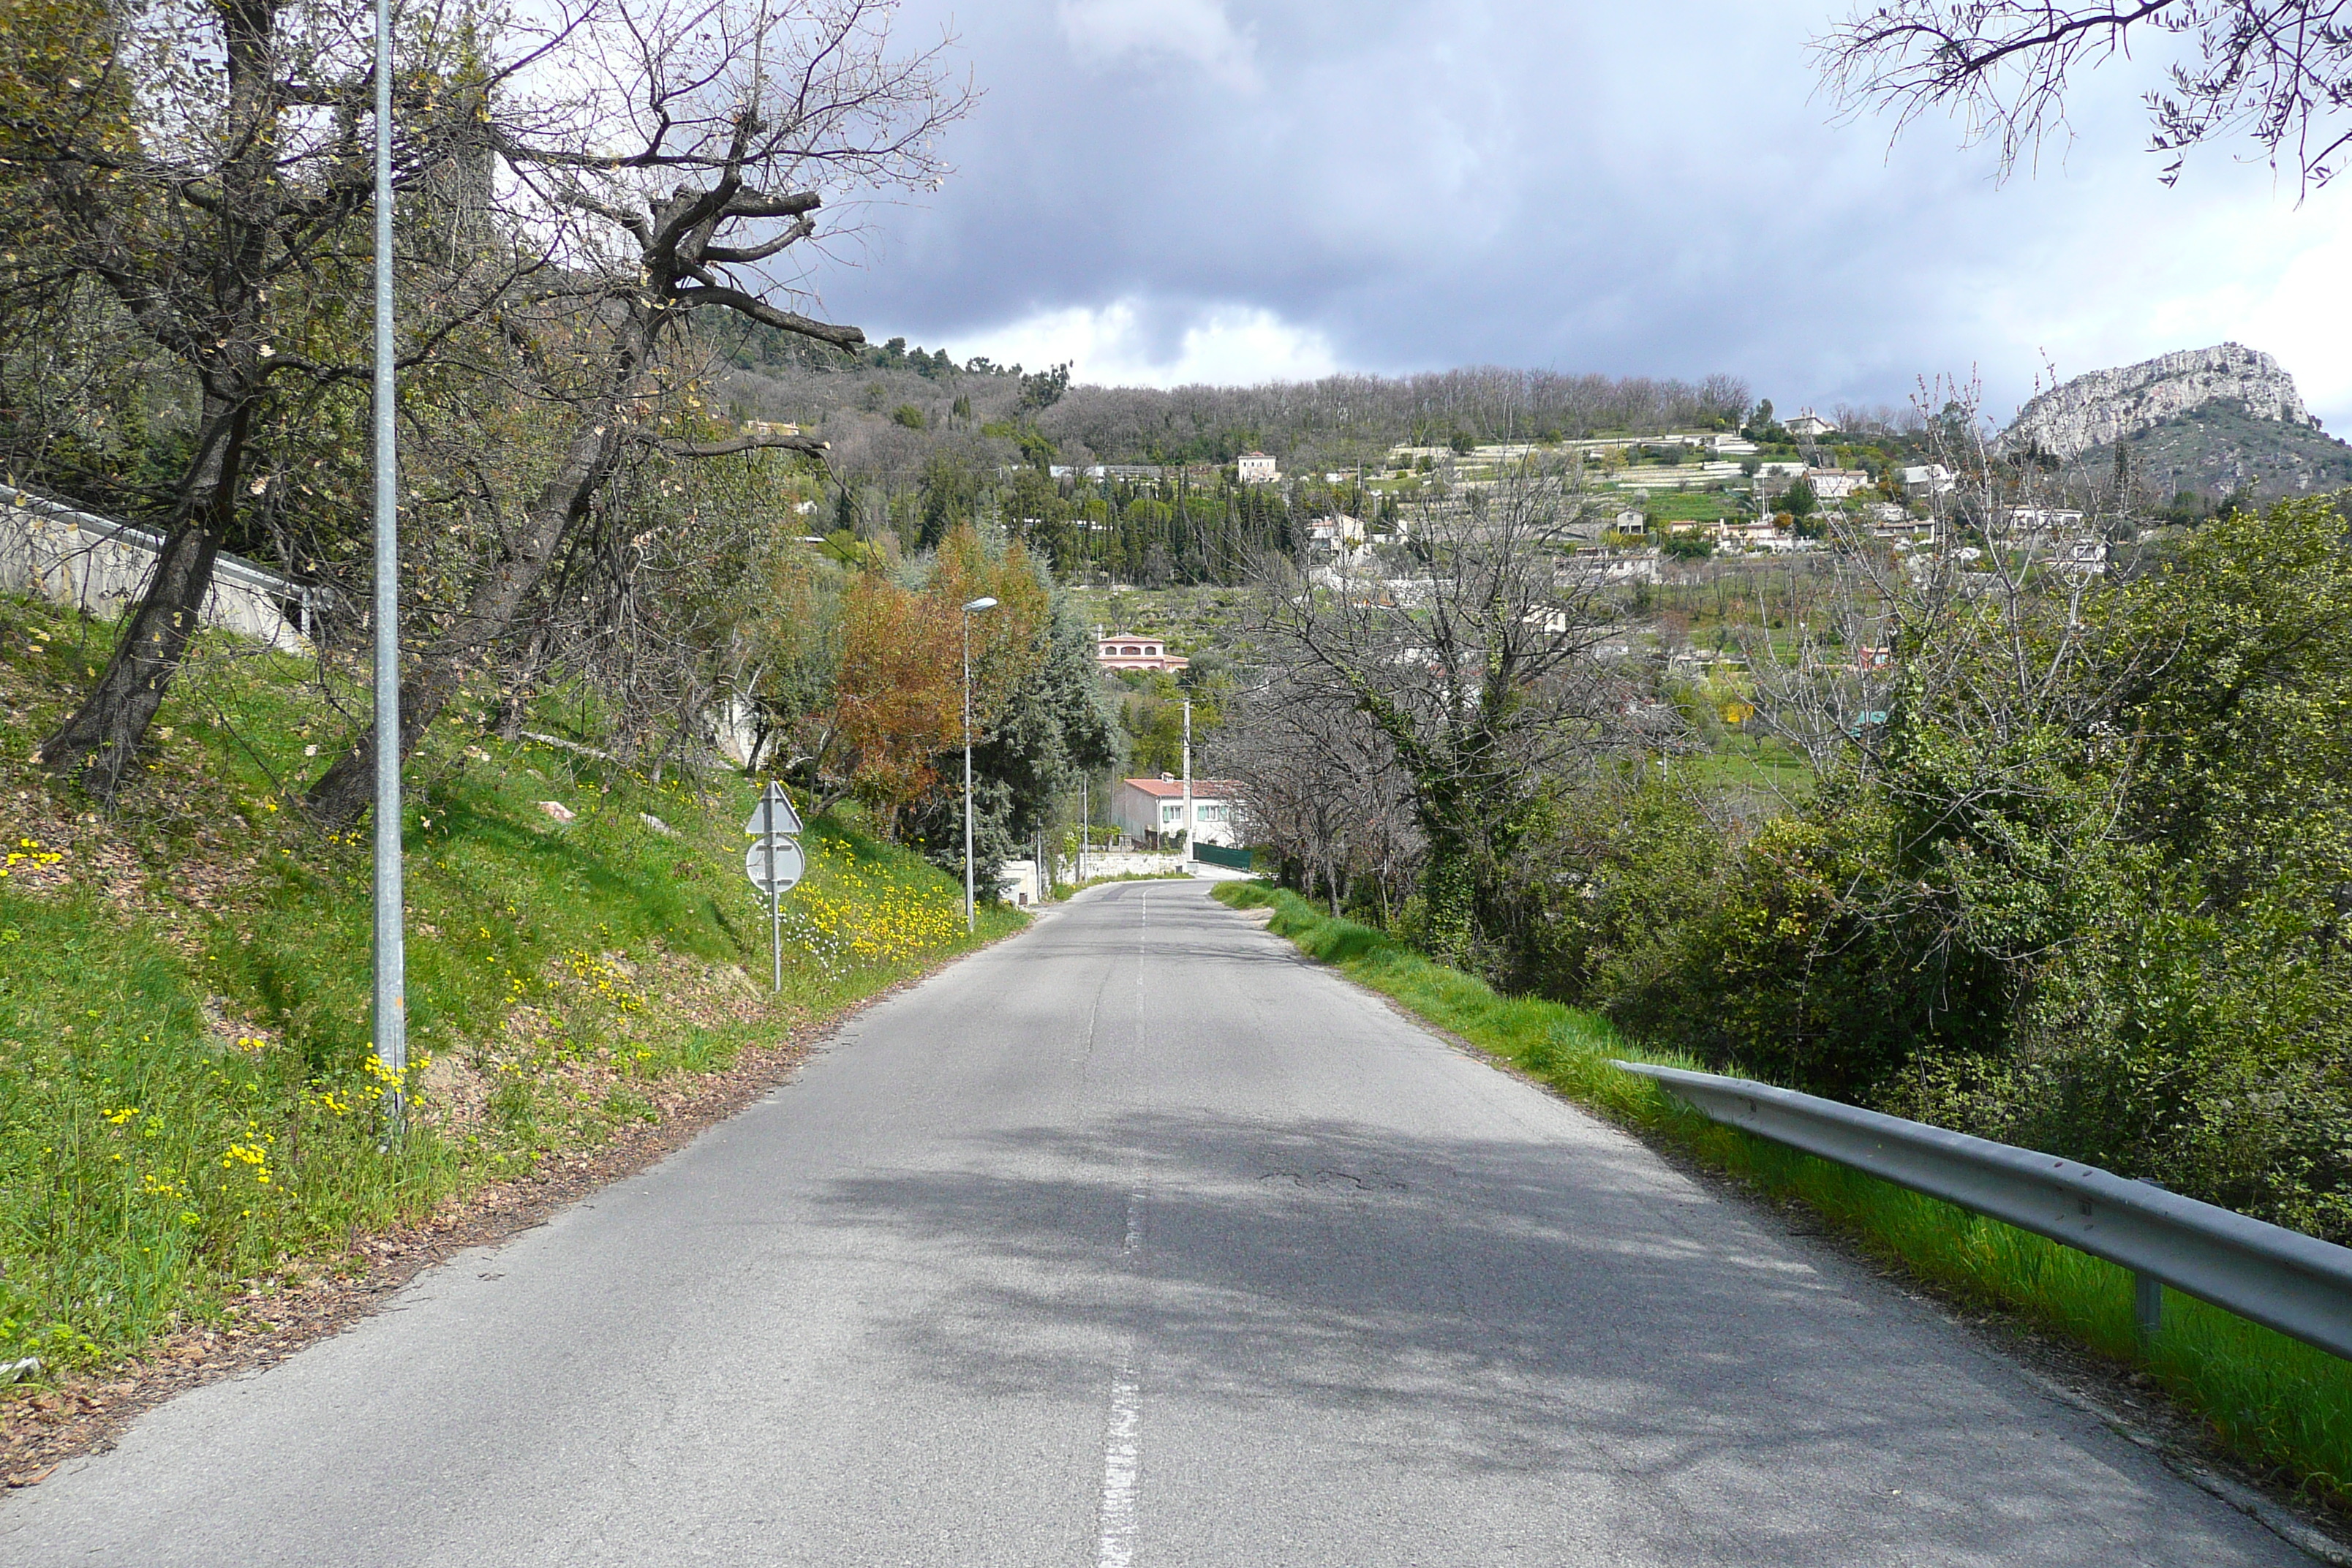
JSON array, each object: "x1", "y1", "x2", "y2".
[{"x1": 948, "y1": 298, "x2": 1338, "y2": 385}]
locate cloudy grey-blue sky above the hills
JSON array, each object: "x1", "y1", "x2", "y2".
[{"x1": 799, "y1": 0, "x2": 2352, "y2": 432}]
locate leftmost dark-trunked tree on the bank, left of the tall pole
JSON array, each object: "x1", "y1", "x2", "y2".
[{"x1": 0, "y1": 0, "x2": 489, "y2": 799}]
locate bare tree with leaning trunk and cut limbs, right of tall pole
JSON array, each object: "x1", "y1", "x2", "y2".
[{"x1": 308, "y1": 0, "x2": 969, "y2": 823}]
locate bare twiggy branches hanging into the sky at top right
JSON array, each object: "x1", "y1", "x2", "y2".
[{"x1": 1814, "y1": 0, "x2": 2352, "y2": 190}]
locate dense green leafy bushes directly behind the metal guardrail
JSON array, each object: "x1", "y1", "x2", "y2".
[{"x1": 1604, "y1": 501, "x2": 2352, "y2": 1239}]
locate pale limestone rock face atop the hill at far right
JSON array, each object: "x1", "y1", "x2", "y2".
[{"x1": 2002, "y1": 343, "x2": 2319, "y2": 459}]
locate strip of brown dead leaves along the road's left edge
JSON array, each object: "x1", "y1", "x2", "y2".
[{"x1": 0, "y1": 921, "x2": 1054, "y2": 1507}]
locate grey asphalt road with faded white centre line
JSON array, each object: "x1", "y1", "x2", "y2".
[{"x1": 0, "y1": 881, "x2": 2307, "y2": 1568}]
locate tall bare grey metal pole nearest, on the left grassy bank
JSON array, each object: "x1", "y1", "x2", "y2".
[{"x1": 372, "y1": 0, "x2": 410, "y2": 1138}]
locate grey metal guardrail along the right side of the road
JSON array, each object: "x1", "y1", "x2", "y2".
[{"x1": 1616, "y1": 1063, "x2": 2352, "y2": 1359}]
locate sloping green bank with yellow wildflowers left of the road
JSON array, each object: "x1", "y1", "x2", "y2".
[{"x1": 0, "y1": 600, "x2": 1023, "y2": 1373}]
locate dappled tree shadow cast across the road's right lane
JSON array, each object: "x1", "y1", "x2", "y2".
[{"x1": 821, "y1": 1115, "x2": 2201, "y2": 1564}]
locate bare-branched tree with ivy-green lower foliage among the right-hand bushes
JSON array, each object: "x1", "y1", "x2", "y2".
[{"x1": 1747, "y1": 385, "x2": 2168, "y2": 1025}]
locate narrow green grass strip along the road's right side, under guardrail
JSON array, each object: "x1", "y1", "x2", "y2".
[{"x1": 1211, "y1": 881, "x2": 2352, "y2": 1509}]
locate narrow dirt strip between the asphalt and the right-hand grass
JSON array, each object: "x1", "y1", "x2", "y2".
[{"x1": 1235, "y1": 893, "x2": 2352, "y2": 1568}]
